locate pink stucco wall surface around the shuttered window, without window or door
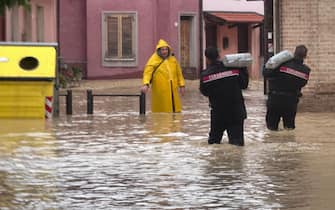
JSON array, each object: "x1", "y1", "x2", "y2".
[{"x1": 86, "y1": 0, "x2": 199, "y2": 79}]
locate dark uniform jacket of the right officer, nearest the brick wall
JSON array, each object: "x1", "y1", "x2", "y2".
[{"x1": 263, "y1": 58, "x2": 310, "y2": 97}]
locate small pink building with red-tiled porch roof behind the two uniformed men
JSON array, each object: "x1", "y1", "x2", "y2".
[{"x1": 203, "y1": 0, "x2": 264, "y2": 79}]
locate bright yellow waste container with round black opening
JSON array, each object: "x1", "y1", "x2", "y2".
[{"x1": 0, "y1": 42, "x2": 57, "y2": 118}]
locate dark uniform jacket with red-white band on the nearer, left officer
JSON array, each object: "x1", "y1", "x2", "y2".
[{"x1": 200, "y1": 61, "x2": 249, "y2": 123}]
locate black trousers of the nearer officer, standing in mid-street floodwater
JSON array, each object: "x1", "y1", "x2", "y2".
[{"x1": 208, "y1": 110, "x2": 244, "y2": 146}]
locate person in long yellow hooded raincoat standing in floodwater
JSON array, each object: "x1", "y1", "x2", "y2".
[{"x1": 141, "y1": 39, "x2": 185, "y2": 112}]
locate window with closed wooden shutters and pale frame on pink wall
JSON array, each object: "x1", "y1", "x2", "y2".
[{"x1": 102, "y1": 12, "x2": 137, "y2": 66}]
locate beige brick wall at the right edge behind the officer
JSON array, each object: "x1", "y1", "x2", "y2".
[{"x1": 279, "y1": 0, "x2": 335, "y2": 111}]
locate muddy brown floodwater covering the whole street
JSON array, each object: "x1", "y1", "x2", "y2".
[{"x1": 0, "y1": 80, "x2": 335, "y2": 210}]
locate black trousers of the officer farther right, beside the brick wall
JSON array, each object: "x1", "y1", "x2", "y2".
[{"x1": 266, "y1": 94, "x2": 298, "y2": 130}]
